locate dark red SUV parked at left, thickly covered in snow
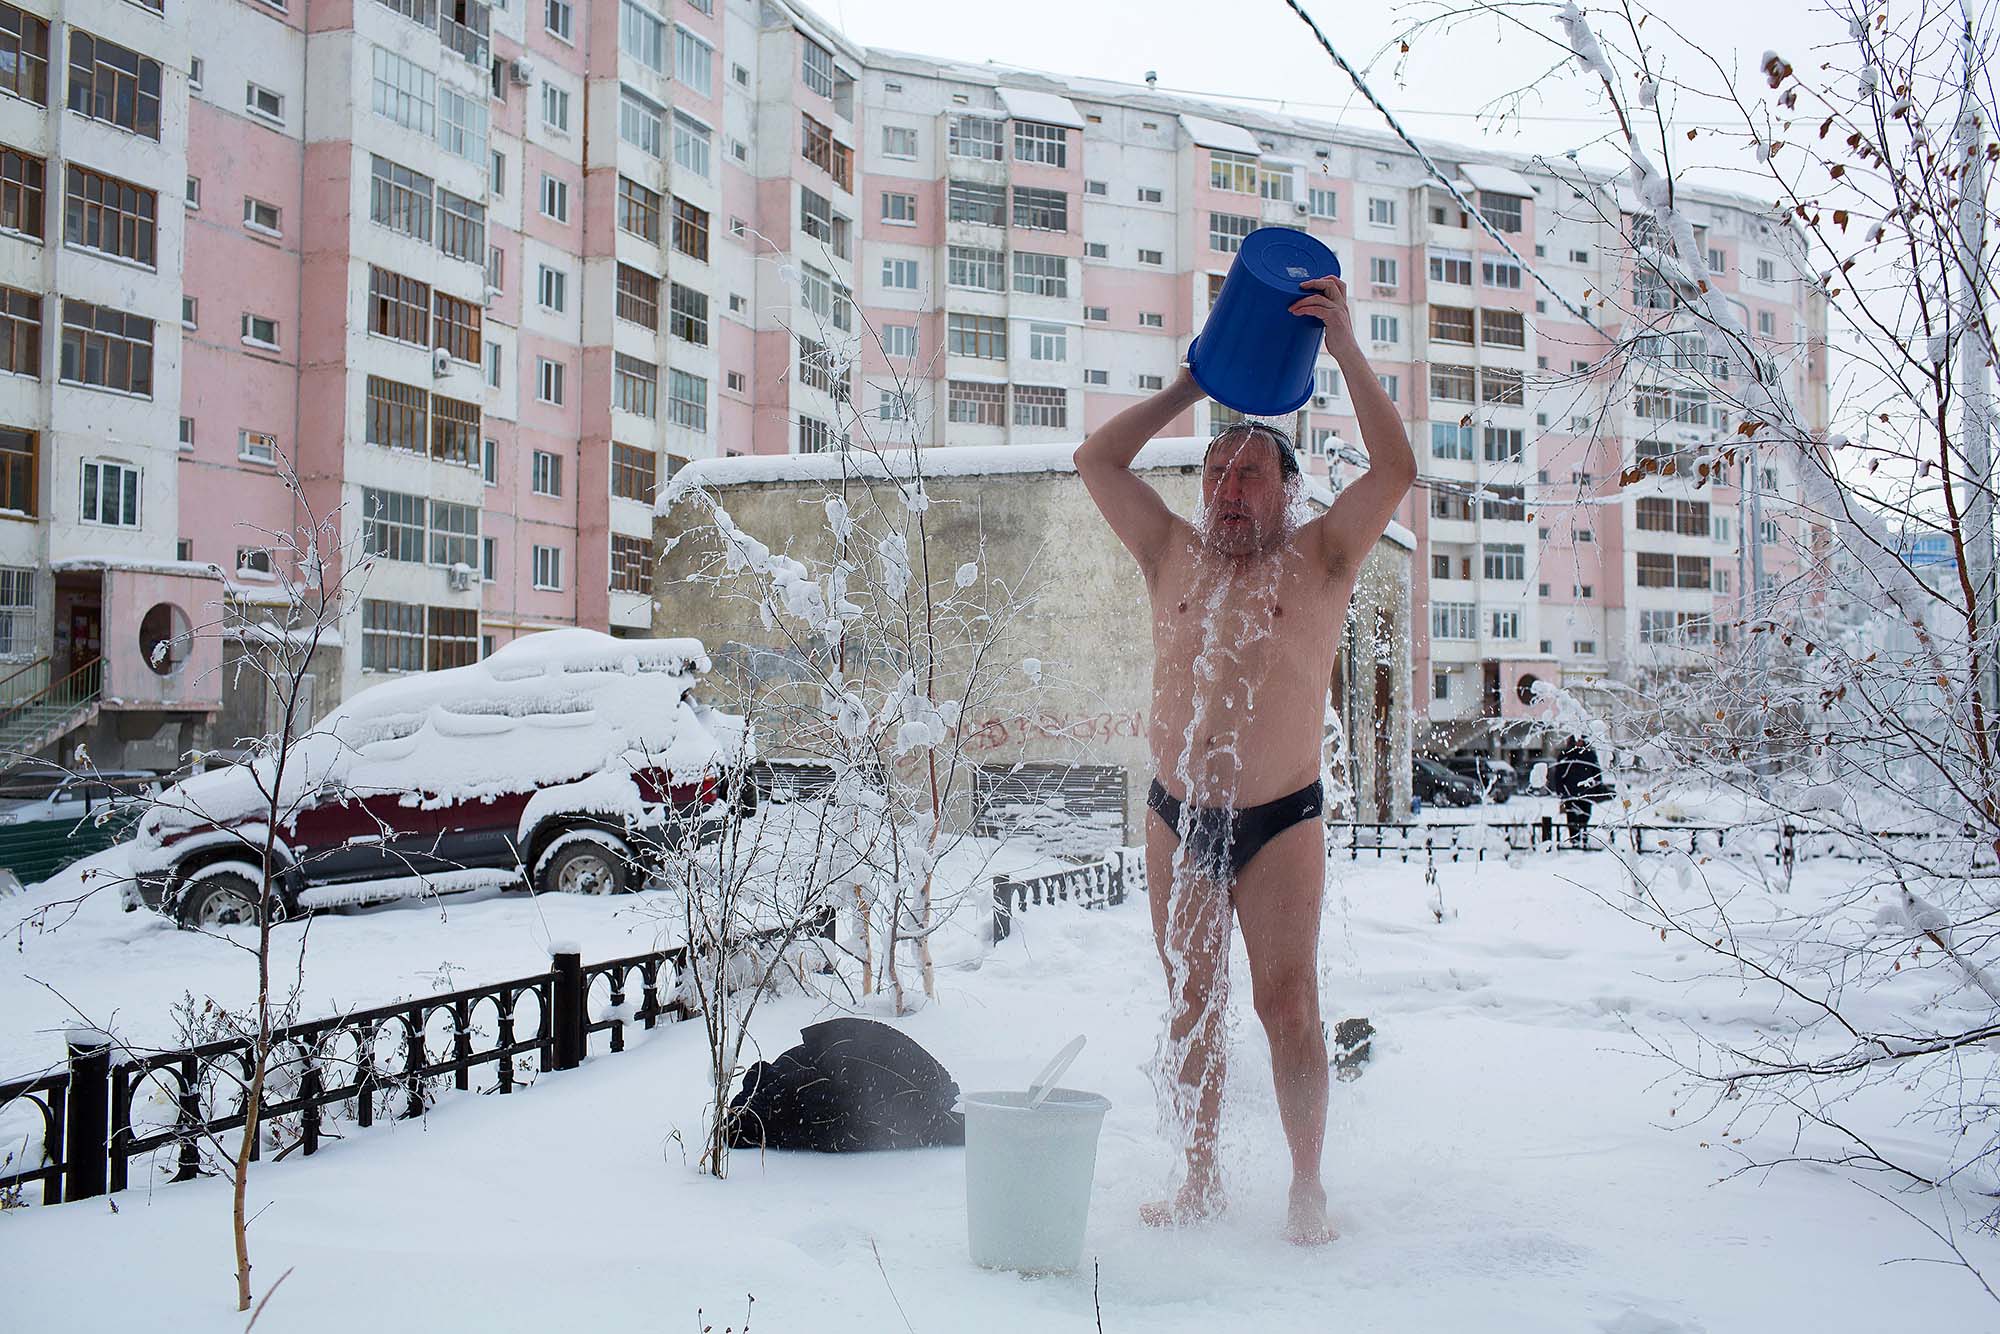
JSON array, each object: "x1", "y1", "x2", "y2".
[{"x1": 126, "y1": 628, "x2": 748, "y2": 926}]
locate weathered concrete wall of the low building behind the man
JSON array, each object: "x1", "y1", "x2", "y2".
[{"x1": 654, "y1": 454, "x2": 1410, "y2": 838}]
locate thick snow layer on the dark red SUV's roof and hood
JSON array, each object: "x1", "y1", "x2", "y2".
[{"x1": 148, "y1": 626, "x2": 718, "y2": 830}]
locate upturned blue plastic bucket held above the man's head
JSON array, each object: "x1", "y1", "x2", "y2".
[{"x1": 1188, "y1": 226, "x2": 1340, "y2": 416}]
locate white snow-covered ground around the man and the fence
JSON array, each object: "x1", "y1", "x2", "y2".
[{"x1": 0, "y1": 836, "x2": 2000, "y2": 1334}]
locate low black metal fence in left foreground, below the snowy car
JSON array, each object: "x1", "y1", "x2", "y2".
[{"x1": 0, "y1": 912, "x2": 834, "y2": 1204}]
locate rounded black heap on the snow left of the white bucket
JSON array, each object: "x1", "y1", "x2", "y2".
[{"x1": 730, "y1": 1018, "x2": 966, "y2": 1154}]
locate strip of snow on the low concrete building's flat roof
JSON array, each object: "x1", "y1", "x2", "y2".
[{"x1": 654, "y1": 436, "x2": 1416, "y2": 552}]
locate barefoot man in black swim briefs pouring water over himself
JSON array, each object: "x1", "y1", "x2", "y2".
[{"x1": 1076, "y1": 278, "x2": 1416, "y2": 1244}]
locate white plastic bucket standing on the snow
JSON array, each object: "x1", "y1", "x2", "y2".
[{"x1": 960, "y1": 1088, "x2": 1112, "y2": 1274}]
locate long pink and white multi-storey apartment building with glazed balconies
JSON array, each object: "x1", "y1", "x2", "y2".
[{"x1": 0, "y1": 0, "x2": 1824, "y2": 766}]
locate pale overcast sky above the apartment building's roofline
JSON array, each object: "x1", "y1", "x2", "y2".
[{"x1": 806, "y1": 0, "x2": 1844, "y2": 192}]
